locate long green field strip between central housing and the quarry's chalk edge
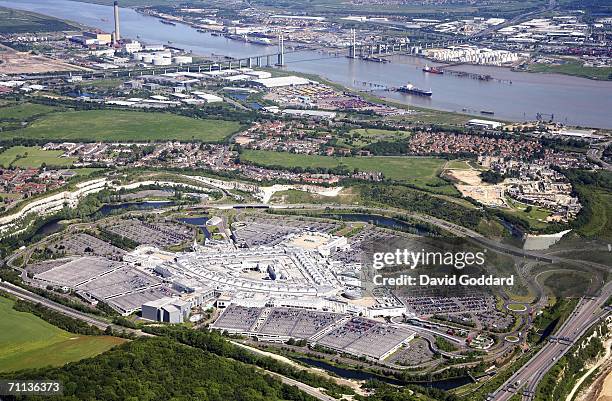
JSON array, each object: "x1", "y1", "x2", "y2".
[{"x1": 241, "y1": 150, "x2": 457, "y2": 194}]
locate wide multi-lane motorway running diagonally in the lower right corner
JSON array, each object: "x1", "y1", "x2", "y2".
[{"x1": 487, "y1": 282, "x2": 612, "y2": 401}]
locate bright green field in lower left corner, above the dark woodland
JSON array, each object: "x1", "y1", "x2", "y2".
[{"x1": 0, "y1": 297, "x2": 125, "y2": 372}]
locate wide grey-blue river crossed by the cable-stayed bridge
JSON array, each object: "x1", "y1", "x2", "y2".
[{"x1": 0, "y1": 0, "x2": 612, "y2": 128}]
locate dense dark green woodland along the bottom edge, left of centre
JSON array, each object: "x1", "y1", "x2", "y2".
[{"x1": 0, "y1": 338, "x2": 314, "y2": 401}]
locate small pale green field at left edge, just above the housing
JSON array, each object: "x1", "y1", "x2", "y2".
[{"x1": 0, "y1": 146, "x2": 76, "y2": 168}]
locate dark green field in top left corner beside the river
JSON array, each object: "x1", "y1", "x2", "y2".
[{"x1": 0, "y1": 7, "x2": 75, "y2": 33}]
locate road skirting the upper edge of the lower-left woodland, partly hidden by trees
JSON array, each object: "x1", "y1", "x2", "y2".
[{"x1": 0, "y1": 281, "x2": 337, "y2": 401}]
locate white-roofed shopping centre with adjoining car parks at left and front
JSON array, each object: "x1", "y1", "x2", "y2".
[{"x1": 28, "y1": 220, "x2": 415, "y2": 360}]
